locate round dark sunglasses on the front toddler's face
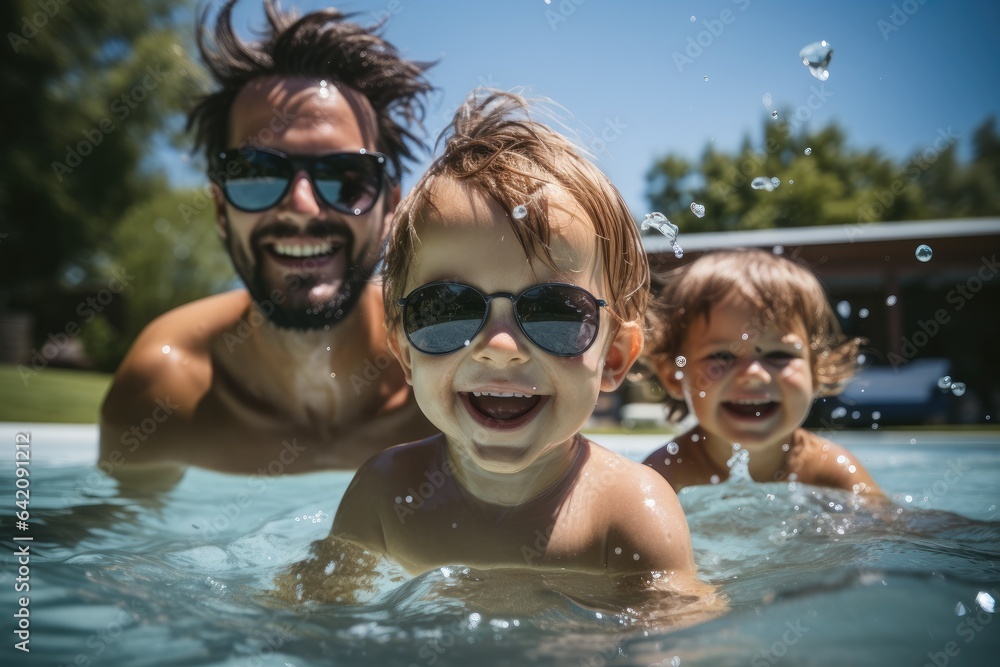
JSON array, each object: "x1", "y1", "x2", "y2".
[{"x1": 397, "y1": 282, "x2": 608, "y2": 357}]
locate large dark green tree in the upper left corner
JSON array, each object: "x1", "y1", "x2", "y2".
[{"x1": 0, "y1": 0, "x2": 202, "y2": 308}]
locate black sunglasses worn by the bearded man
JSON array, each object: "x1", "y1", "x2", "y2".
[{"x1": 212, "y1": 148, "x2": 388, "y2": 215}]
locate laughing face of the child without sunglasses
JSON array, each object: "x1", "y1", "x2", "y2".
[{"x1": 658, "y1": 295, "x2": 814, "y2": 454}]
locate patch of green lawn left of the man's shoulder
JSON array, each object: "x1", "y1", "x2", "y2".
[{"x1": 0, "y1": 366, "x2": 112, "y2": 424}]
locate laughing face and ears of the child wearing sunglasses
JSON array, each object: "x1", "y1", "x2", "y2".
[{"x1": 390, "y1": 184, "x2": 641, "y2": 473}]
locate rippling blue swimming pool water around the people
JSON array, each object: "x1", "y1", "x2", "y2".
[{"x1": 0, "y1": 424, "x2": 1000, "y2": 667}]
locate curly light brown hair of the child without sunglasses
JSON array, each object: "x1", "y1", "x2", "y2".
[{"x1": 646, "y1": 248, "x2": 864, "y2": 421}]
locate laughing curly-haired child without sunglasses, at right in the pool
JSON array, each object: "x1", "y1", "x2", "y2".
[{"x1": 644, "y1": 249, "x2": 882, "y2": 496}]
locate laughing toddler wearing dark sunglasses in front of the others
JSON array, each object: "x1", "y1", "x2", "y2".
[{"x1": 300, "y1": 91, "x2": 716, "y2": 612}]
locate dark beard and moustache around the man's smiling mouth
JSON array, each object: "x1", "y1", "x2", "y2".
[{"x1": 226, "y1": 219, "x2": 378, "y2": 331}]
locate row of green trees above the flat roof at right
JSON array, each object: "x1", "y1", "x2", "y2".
[{"x1": 646, "y1": 113, "x2": 1000, "y2": 232}]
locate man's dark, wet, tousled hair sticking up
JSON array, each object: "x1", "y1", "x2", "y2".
[{"x1": 187, "y1": 0, "x2": 433, "y2": 175}]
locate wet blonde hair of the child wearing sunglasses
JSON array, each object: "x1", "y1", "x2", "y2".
[{"x1": 382, "y1": 90, "x2": 649, "y2": 330}]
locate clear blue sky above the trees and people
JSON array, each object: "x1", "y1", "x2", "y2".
[{"x1": 174, "y1": 0, "x2": 1000, "y2": 217}]
